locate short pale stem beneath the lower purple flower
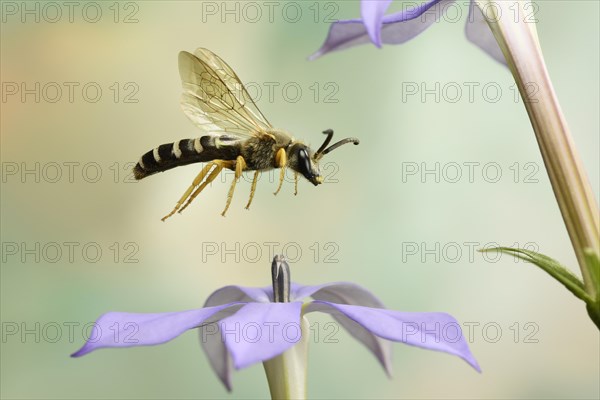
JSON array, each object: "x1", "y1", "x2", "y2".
[{"x1": 263, "y1": 317, "x2": 309, "y2": 400}]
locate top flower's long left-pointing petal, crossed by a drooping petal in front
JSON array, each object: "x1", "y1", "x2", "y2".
[{"x1": 309, "y1": 0, "x2": 448, "y2": 60}]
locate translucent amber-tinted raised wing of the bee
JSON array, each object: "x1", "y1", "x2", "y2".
[{"x1": 179, "y1": 48, "x2": 272, "y2": 138}]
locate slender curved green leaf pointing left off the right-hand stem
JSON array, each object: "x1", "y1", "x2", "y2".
[{"x1": 479, "y1": 247, "x2": 595, "y2": 304}]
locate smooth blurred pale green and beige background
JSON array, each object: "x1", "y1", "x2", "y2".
[{"x1": 0, "y1": 0, "x2": 600, "y2": 399}]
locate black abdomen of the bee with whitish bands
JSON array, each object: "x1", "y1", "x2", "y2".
[{"x1": 133, "y1": 135, "x2": 240, "y2": 179}]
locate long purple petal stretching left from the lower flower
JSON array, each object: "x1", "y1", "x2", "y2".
[{"x1": 71, "y1": 304, "x2": 244, "y2": 357}]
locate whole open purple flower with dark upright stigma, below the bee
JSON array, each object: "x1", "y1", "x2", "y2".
[{"x1": 72, "y1": 256, "x2": 480, "y2": 390}]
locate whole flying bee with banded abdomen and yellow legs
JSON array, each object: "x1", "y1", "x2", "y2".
[{"x1": 133, "y1": 48, "x2": 359, "y2": 221}]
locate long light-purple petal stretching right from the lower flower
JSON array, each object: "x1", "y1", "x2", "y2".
[{"x1": 305, "y1": 301, "x2": 481, "y2": 372}]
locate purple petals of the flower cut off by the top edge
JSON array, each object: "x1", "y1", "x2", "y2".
[{"x1": 310, "y1": 0, "x2": 506, "y2": 64}]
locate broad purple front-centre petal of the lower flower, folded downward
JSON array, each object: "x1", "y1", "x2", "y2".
[{"x1": 219, "y1": 302, "x2": 302, "y2": 369}]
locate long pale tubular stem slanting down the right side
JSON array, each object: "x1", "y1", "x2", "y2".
[{"x1": 477, "y1": 0, "x2": 600, "y2": 298}]
